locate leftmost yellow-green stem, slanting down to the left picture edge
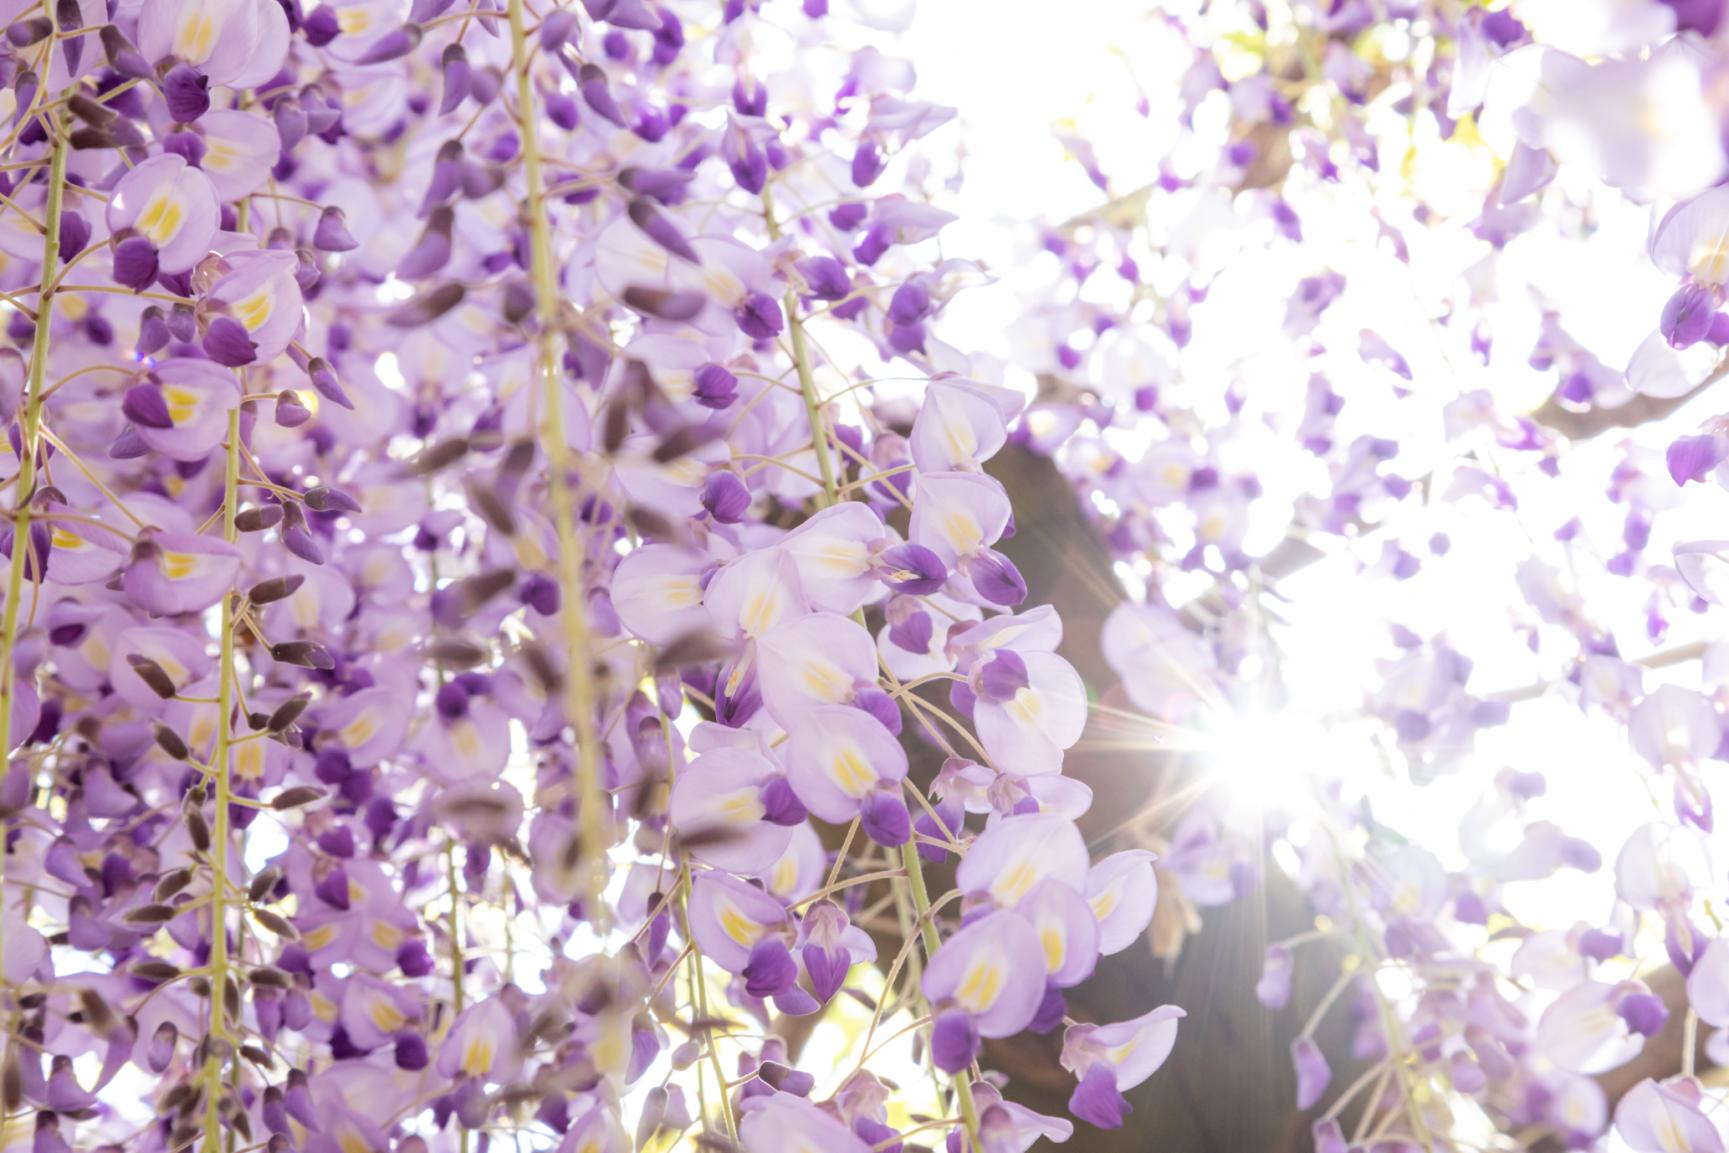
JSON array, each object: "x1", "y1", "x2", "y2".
[{"x1": 0, "y1": 121, "x2": 66, "y2": 1002}]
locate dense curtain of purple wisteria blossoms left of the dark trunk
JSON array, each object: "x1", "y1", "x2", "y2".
[{"x1": 0, "y1": 0, "x2": 1183, "y2": 1153}]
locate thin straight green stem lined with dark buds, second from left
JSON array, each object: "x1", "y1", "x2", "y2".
[{"x1": 204, "y1": 405, "x2": 240, "y2": 1153}]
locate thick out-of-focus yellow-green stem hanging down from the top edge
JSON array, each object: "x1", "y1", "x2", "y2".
[{"x1": 510, "y1": 0, "x2": 610, "y2": 925}]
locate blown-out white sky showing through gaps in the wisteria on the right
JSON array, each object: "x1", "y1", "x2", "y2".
[{"x1": 901, "y1": 0, "x2": 1729, "y2": 974}]
